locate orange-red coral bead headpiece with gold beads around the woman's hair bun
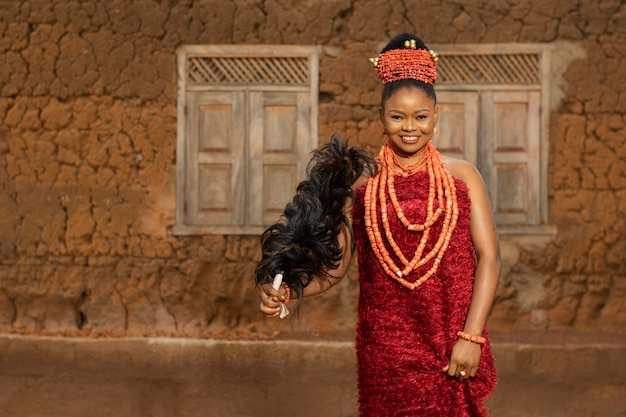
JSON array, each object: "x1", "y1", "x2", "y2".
[{"x1": 370, "y1": 40, "x2": 439, "y2": 84}]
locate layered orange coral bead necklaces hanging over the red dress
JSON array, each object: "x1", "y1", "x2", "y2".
[{"x1": 364, "y1": 141, "x2": 459, "y2": 290}]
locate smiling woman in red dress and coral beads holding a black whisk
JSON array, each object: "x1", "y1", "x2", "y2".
[{"x1": 257, "y1": 34, "x2": 500, "y2": 417}]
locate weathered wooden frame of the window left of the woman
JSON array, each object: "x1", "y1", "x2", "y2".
[{"x1": 172, "y1": 45, "x2": 322, "y2": 235}]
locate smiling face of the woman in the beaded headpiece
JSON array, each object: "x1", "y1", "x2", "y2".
[{"x1": 380, "y1": 87, "x2": 439, "y2": 158}]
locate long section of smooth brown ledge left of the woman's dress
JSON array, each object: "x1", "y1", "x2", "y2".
[{"x1": 0, "y1": 336, "x2": 357, "y2": 417}]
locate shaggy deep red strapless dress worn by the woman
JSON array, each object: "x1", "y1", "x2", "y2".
[{"x1": 353, "y1": 172, "x2": 496, "y2": 417}]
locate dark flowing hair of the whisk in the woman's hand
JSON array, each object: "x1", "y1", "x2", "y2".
[{"x1": 255, "y1": 135, "x2": 377, "y2": 308}]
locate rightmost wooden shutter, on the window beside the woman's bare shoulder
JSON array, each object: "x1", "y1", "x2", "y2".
[{"x1": 480, "y1": 91, "x2": 541, "y2": 225}]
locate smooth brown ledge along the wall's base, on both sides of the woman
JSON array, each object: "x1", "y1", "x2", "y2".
[{"x1": 0, "y1": 335, "x2": 626, "y2": 417}]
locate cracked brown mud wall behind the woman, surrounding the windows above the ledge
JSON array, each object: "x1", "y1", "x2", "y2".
[{"x1": 0, "y1": 0, "x2": 626, "y2": 337}]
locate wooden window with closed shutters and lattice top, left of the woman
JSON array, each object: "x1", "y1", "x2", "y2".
[{"x1": 174, "y1": 45, "x2": 319, "y2": 234}]
